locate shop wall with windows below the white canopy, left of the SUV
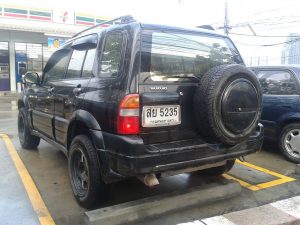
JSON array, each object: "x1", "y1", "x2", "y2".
[{"x1": 0, "y1": 30, "x2": 65, "y2": 91}]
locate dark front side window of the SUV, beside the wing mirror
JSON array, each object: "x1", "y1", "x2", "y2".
[{"x1": 43, "y1": 48, "x2": 72, "y2": 83}]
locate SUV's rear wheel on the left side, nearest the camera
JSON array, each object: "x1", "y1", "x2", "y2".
[{"x1": 68, "y1": 135, "x2": 108, "y2": 209}]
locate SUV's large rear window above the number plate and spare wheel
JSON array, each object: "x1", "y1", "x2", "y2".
[{"x1": 140, "y1": 30, "x2": 243, "y2": 82}]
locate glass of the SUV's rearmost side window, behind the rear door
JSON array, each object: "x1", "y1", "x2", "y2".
[{"x1": 100, "y1": 32, "x2": 124, "y2": 77}]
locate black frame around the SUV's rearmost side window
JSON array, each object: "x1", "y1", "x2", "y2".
[{"x1": 98, "y1": 29, "x2": 128, "y2": 79}]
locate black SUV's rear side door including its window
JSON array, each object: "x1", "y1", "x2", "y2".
[{"x1": 53, "y1": 43, "x2": 96, "y2": 144}]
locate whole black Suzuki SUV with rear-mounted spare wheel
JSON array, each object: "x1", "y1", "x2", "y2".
[{"x1": 18, "y1": 16, "x2": 263, "y2": 207}]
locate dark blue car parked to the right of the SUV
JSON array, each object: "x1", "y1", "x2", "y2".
[{"x1": 252, "y1": 65, "x2": 300, "y2": 163}]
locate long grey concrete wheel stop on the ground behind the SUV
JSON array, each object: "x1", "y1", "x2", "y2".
[{"x1": 85, "y1": 181, "x2": 241, "y2": 225}]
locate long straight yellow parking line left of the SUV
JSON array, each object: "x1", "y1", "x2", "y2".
[{"x1": 0, "y1": 134, "x2": 55, "y2": 225}]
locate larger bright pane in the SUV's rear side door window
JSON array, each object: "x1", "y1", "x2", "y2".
[{"x1": 67, "y1": 50, "x2": 86, "y2": 79}]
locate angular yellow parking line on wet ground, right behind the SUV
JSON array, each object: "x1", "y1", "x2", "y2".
[{"x1": 223, "y1": 160, "x2": 296, "y2": 191}]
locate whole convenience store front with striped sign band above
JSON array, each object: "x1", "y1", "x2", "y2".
[{"x1": 0, "y1": 5, "x2": 109, "y2": 91}]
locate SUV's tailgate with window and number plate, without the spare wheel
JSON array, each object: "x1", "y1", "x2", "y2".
[{"x1": 139, "y1": 30, "x2": 242, "y2": 143}]
